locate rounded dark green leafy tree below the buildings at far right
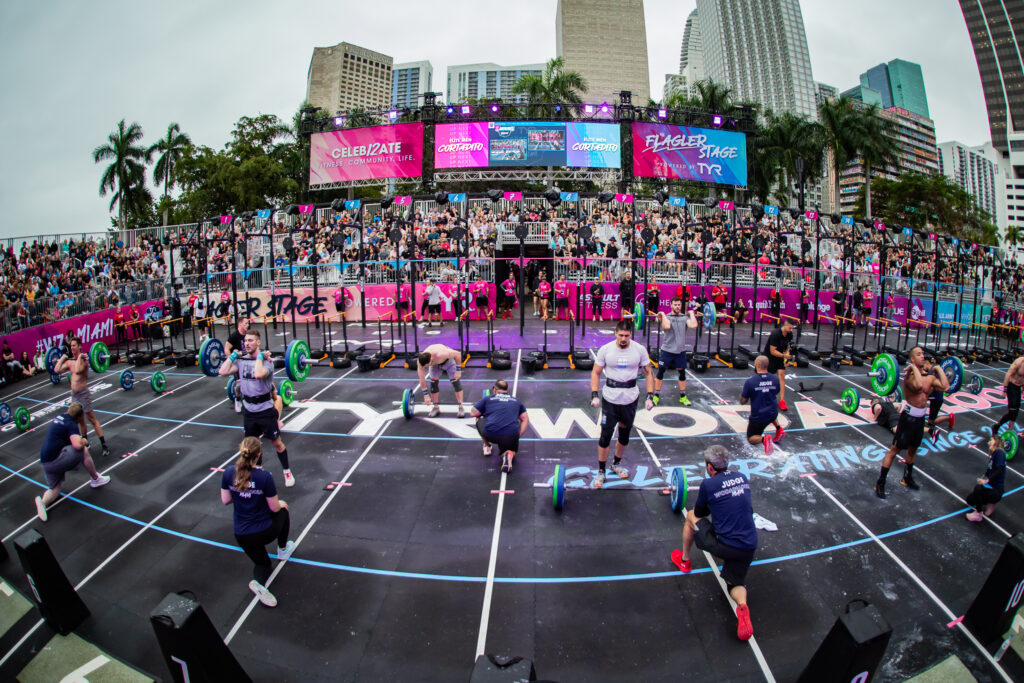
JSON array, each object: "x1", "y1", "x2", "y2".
[{"x1": 857, "y1": 173, "x2": 998, "y2": 245}]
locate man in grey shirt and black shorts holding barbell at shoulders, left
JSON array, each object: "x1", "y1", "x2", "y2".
[{"x1": 217, "y1": 330, "x2": 295, "y2": 487}]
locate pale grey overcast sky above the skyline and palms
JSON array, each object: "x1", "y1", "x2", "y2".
[{"x1": 0, "y1": 0, "x2": 988, "y2": 241}]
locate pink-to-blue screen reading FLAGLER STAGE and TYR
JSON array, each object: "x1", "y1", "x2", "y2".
[{"x1": 633, "y1": 123, "x2": 746, "y2": 186}]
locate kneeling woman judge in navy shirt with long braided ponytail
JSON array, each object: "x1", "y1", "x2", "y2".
[{"x1": 220, "y1": 436, "x2": 295, "y2": 607}]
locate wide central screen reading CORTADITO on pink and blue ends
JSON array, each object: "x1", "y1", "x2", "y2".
[{"x1": 434, "y1": 121, "x2": 622, "y2": 168}]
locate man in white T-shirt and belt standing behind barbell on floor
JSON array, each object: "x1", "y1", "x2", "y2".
[{"x1": 590, "y1": 319, "x2": 654, "y2": 488}]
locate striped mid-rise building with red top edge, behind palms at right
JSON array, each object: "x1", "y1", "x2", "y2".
[{"x1": 839, "y1": 106, "x2": 939, "y2": 213}]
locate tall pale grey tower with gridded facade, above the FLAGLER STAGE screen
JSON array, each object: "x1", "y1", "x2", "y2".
[{"x1": 696, "y1": 0, "x2": 817, "y2": 121}]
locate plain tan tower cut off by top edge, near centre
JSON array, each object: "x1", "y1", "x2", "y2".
[{"x1": 555, "y1": 0, "x2": 650, "y2": 105}]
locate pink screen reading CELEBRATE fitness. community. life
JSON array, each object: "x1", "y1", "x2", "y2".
[{"x1": 309, "y1": 123, "x2": 423, "y2": 189}]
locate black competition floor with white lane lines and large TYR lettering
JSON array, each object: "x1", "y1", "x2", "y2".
[{"x1": 0, "y1": 318, "x2": 1024, "y2": 682}]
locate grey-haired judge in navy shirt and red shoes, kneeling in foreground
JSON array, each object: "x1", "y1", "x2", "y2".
[{"x1": 672, "y1": 445, "x2": 758, "y2": 640}]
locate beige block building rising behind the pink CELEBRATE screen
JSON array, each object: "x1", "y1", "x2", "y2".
[{"x1": 306, "y1": 43, "x2": 393, "y2": 113}]
